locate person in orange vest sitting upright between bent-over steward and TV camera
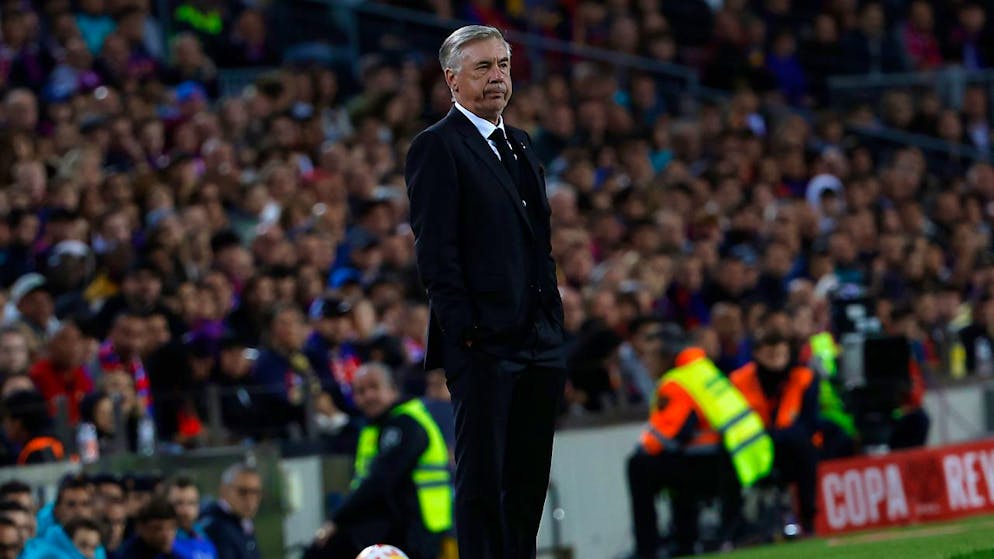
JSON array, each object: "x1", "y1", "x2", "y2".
[{"x1": 729, "y1": 330, "x2": 819, "y2": 534}]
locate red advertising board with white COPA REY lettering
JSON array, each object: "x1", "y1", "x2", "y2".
[{"x1": 815, "y1": 439, "x2": 994, "y2": 535}]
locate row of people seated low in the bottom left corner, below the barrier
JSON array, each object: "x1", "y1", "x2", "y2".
[{"x1": 0, "y1": 464, "x2": 263, "y2": 559}]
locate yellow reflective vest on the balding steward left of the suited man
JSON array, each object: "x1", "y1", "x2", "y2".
[{"x1": 352, "y1": 399, "x2": 453, "y2": 533}]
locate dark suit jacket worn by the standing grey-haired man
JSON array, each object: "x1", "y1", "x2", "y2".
[{"x1": 406, "y1": 107, "x2": 562, "y2": 369}]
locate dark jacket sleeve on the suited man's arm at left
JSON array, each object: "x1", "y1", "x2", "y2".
[{"x1": 405, "y1": 130, "x2": 473, "y2": 342}]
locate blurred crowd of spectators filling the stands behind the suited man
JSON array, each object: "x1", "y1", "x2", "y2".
[{"x1": 0, "y1": 0, "x2": 994, "y2": 549}]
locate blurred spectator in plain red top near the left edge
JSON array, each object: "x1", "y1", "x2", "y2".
[{"x1": 31, "y1": 321, "x2": 93, "y2": 425}]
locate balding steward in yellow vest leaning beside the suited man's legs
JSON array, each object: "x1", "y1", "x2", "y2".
[{"x1": 305, "y1": 364, "x2": 453, "y2": 559}]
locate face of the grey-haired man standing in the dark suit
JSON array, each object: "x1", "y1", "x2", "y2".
[{"x1": 445, "y1": 39, "x2": 511, "y2": 122}]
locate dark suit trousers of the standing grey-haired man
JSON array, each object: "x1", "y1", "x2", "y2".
[{"x1": 445, "y1": 344, "x2": 566, "y2": 559}]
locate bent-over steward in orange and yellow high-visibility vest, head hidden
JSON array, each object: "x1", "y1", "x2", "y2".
[{"x1": 628, "y1": 347, "x2": 773, "y2": 558}]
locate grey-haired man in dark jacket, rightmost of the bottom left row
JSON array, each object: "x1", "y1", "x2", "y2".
[{"x1": 202, "y1": 464, "x2": 262, "y2": 559}]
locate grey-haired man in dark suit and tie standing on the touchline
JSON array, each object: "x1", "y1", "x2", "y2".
[{"x1": 406, "y1": 26, "x2": 565, "y2": 559}]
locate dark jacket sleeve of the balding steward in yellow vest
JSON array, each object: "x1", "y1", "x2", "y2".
[{"x1": 333, "y1": 416, "x2": 428, "y2": 524}]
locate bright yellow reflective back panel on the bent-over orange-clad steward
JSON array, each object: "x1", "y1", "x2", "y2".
[{"x1": 661, "y1": 359, "x2": 773, "y2": 487}]
